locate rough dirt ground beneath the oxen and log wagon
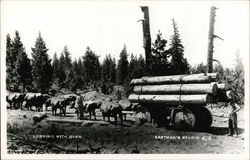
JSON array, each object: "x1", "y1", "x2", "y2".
[{"x1": 7, "y1": 104, "x2": 244, "y2": 154}]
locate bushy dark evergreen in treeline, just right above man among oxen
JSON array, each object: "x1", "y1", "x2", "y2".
[{"x1": 83, "y1": 47, "x2": 101, "y2": 84}]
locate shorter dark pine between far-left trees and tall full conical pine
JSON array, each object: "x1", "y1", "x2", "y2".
[{"x1": 16, "y1": 48, "x2": 32, "y2": 92}]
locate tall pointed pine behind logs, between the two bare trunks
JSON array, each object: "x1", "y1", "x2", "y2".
[{"x1": 169, "y1": 19, "x2": 189, "y2": 75}]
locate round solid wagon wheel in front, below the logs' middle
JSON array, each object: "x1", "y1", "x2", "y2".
[{"x1": 174, "y1": 108, "x2": 196, "y2": 130}]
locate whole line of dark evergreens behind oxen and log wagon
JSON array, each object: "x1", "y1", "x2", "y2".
[{"x1": 6, "y1": 20, "x2": 244, "y2": 103}]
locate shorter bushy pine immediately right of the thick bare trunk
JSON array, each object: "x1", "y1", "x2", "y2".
[{"x1": 150, "y1": 31, "x2": 170, "y2": 76}]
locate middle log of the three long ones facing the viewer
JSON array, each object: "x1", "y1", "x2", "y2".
[{"x1": 134, "y1": 83, "x2": 218, "y2": 95}]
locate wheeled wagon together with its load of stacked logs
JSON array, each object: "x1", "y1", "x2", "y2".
[{"x1": 129, "y1": 73, "x2": 227, "y2": 130}]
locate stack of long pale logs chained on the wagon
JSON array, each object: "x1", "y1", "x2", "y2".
[{"x1": 129, "y1": 73, "x2": 227, "y2": 105}]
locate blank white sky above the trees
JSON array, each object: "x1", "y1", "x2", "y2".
[{"x1": 1, "y1": 0, "x2": 249, "y2": 67}]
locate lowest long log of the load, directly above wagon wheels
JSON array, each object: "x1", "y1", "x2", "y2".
[{"x1": 128, "y1": 94, "x2": 210, "y2": 105}]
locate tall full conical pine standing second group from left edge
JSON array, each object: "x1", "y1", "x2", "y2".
[{"x1": 31, "y1": 32, "x2": 53, "y2": 93}]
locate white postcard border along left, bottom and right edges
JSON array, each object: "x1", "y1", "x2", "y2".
[{"x1": 1, "y1": 1, "x2": 249, "y2": 160}]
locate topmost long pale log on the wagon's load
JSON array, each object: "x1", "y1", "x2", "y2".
[{"x1": 131, "y1": 73, "x2": 212, "y2": 85}]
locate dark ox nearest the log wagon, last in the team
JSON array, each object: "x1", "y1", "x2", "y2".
[{"x1": 100, "y1": 99, "x2": 122, "y2": 124}]
